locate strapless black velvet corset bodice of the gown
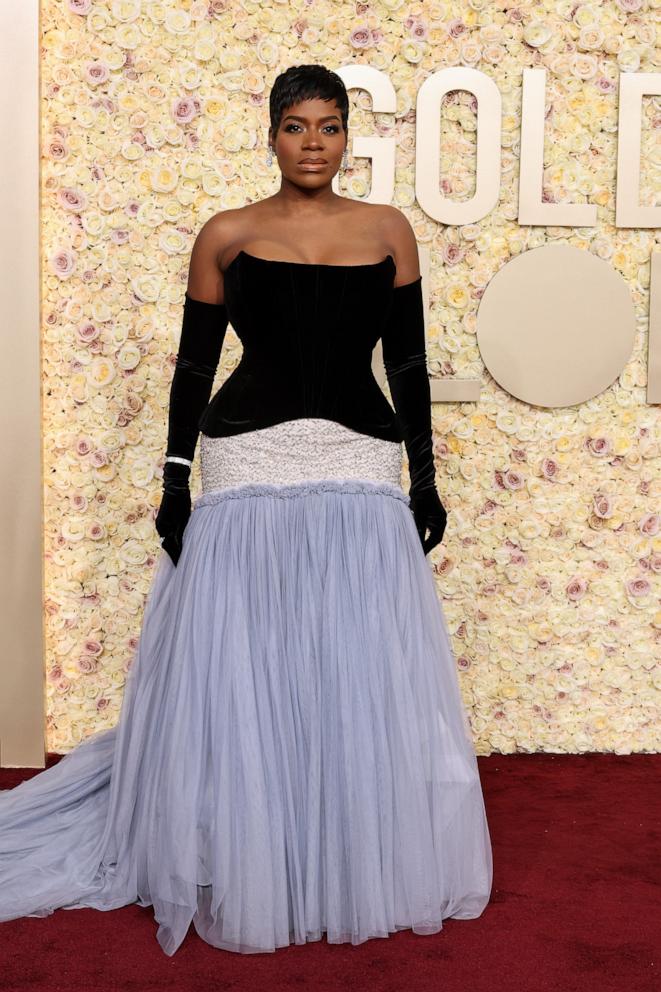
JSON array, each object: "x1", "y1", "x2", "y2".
[{"x1": 199, "y1": 251, "x2": 404, "y2": 441}]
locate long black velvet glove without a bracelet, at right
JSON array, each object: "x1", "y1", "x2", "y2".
[{"x1": 381, "y1": 276, "x2": 447, "y2": 554}]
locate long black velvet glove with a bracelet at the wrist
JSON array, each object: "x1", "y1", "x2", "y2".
[{"x1": 155, "y1": 292, "x2": 229, "y2": 565}]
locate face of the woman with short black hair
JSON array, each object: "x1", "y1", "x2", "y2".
[{"x1": 269, "y1": 99, "x2": 346, "y2": 186}]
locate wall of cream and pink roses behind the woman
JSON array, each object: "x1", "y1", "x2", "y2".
[{"x1": 40, "y1": 0, "x2": 661, "y2": 754}]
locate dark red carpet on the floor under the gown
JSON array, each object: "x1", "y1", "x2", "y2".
[{"x1": 0, "y1": 754, "x2": 661, "y2": 992}]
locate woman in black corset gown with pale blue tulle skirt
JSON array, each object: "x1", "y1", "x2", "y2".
[{"x1": 0, "y1": 65, "x2": 492, "y2": 955}]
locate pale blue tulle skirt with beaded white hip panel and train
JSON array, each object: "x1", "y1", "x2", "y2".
[{"x1": 0, "y1": 418, "x2": 492, "y2": 955}]
